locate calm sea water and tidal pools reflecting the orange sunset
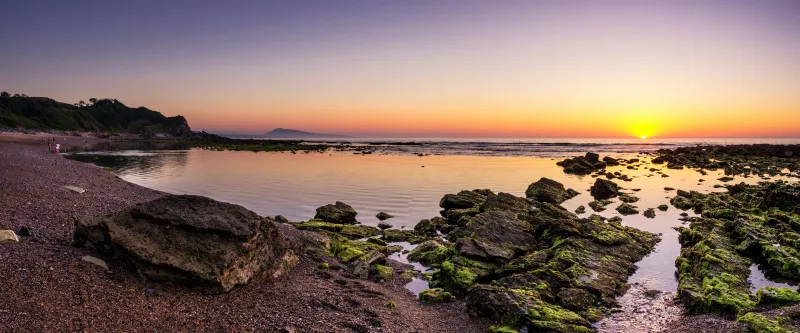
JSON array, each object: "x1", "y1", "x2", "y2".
[{"x1": 70, "y1": 139, "x2": 800, "y2": 292}]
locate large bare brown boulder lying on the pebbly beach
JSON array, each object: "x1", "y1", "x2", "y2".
[{"x1": 74, "y1": 195, "x2": 297, "y2": 291}]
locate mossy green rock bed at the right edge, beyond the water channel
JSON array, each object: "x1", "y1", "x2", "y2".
[{"x1": 673, "y1": 182, "x2": 800, "y2": 326}]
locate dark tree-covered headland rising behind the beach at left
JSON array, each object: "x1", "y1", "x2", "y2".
[{"x1": 0, "y1": 94, "x2": 192, "y2": 136}]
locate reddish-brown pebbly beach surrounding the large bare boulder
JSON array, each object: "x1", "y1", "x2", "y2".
[{"x1": 0, "y1": 134, "x2": 490, "y2": 333}]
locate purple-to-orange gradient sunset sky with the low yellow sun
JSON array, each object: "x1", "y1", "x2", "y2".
[{"x1": 0, "y1": 0, "x2": 800, "y2": 138}]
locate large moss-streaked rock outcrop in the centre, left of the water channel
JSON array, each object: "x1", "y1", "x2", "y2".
[{"x1": 409, "y1": 181, "x2": 659, "y2": 332}]
